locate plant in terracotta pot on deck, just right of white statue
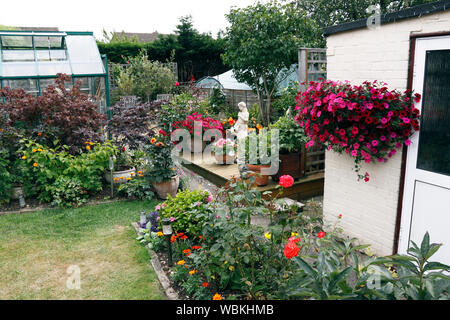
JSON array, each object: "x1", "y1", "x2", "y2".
[{"x1": 245, "y1": 130, "x2": 271, "y2": 186}]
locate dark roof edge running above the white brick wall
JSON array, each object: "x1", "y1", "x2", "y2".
[{"x1": 324, "y1": 0, "x2": 450, "y2": 36}]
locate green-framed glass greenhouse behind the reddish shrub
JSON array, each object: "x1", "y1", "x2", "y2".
[{"x1": 0, "y1": 31, "x2": 109, "y2": 112}]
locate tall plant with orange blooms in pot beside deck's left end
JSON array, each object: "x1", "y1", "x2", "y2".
[{"x1": 146, "y1": 134, "x2": 180, "y2": 200}]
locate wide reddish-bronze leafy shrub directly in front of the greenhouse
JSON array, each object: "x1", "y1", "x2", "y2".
[{"x1": 0, "y1": 74, "x2": 106, "y2": 154}]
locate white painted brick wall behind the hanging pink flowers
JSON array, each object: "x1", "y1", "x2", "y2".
[{"x1": 323, "y1": 10, "x2": 450, "y2": 255}]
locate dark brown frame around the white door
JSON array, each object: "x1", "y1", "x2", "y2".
[{"x1": 392, "y1": 31, "x2": 450, "y2": 254}]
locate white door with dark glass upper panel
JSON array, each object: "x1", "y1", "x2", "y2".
[{"x1": 399, "y1": 36, "x2": 450, "y2": 264}]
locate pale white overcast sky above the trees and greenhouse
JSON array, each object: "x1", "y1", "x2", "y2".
[{"x1": 0, "y1": 0, "x2": 260, "y2": 38}]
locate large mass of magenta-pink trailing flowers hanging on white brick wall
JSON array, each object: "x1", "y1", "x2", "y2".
[{"x1": 295, "y1": 80, "x2": 421, "y2": 182}]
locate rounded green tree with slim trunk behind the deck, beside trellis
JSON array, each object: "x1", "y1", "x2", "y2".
[{"x1": 222, "y1": 1, "x2": 323, "y2": 125}]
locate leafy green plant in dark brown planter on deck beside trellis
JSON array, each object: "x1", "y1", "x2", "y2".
[{"x1": 271, "y1": 112, "x2": 309, "y2": 181}]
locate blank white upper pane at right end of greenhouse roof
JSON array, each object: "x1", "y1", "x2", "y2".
[{"x1": 66, "y1": 36, "x2": 105, "y2": 75}]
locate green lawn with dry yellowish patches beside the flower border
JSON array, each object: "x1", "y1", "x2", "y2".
[{"x1": 0, "y1": 201, "x2": 166, "y2": 300}]
